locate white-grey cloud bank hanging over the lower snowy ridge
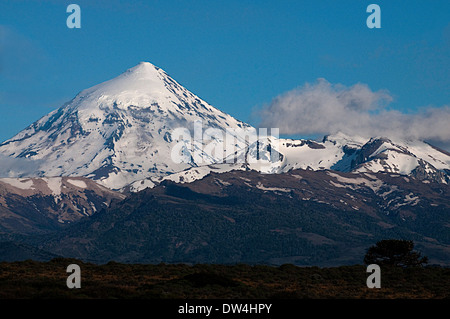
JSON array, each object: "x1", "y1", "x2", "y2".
[{"x1": 257, "y1": 79, "x2": 450, "y2": 145}]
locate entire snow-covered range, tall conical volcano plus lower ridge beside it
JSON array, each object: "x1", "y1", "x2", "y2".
[{"x1": 0, "y1": 62, "x2": 450, "y2": 191}]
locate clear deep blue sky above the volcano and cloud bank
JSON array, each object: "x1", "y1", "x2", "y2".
[{"x1": 0, "y1": 0, "x2": 450, "y2": 146}]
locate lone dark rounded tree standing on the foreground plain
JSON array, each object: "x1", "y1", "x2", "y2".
[{"x1": 364, "y1": 239, "x2": 428, "y2": 267}]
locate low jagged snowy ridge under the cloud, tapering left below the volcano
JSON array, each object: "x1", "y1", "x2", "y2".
[{"x1": 128, "y1": 133, "x2": 450, "y2": 191}]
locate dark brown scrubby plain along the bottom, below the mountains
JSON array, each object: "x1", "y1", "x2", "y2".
[{"x1": 0, "y1": 258, "x2": 450, "y2": 299}]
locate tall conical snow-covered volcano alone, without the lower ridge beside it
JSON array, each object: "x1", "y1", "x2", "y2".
[{"x1": 0, "y1": 62, "x2": 249, "y2": 189}]
